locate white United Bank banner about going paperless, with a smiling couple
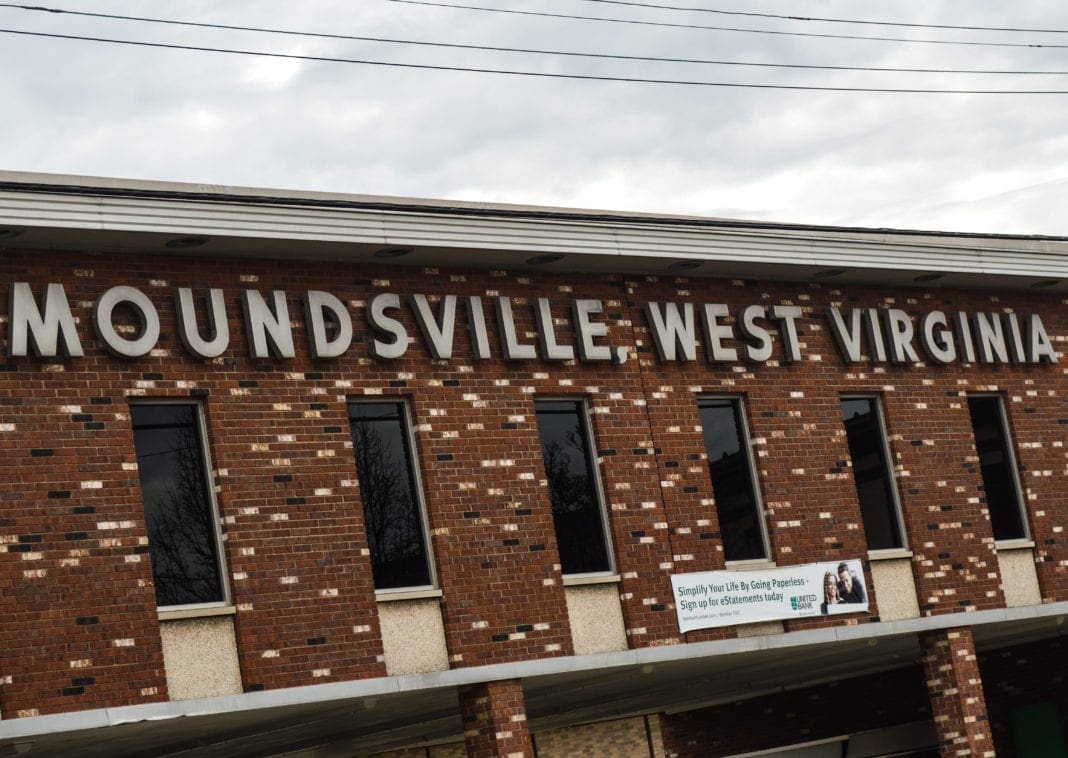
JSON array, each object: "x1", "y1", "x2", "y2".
[{"x1": 671, "y1": 560, "x2": 868, "y2": 632}]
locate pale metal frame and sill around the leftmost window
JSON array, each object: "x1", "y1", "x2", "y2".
[{"x1": 129, "y1": 397, "x2": 234, "y2": 619}]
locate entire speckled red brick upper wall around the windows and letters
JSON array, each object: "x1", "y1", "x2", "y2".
[{"x1": 0, "y1": 244, "x2": 1068, "y2": 716}]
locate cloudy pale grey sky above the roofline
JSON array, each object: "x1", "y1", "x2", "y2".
[{"x1": 0, "y1": 0, "x2": 1068, "y2": 235}]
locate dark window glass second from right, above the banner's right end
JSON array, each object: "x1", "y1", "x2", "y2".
[{"x1": 842, "y1": 397, "x2": 905, "y2": 550}]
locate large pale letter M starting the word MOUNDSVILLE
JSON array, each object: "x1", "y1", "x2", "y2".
[{"x1": 7, "y1": 282, "x2": 83, "y2": 358}]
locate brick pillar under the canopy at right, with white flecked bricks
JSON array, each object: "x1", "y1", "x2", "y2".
[{"x1": 920, "y1": 628, "x2": 994, "y2": 758}]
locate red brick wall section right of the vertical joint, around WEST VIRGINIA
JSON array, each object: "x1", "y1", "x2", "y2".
[{"x1": 632, "y1": 280, "x2": 1068, "y2": 641}]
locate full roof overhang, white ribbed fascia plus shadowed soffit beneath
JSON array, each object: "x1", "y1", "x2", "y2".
[{"x1": 0, "y1": 172, "x2": 1068, "y2": 286}]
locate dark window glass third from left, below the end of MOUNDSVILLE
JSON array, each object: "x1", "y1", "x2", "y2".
[{"x1": 534, "y1": 400, "x2": 611, "y2": 573}]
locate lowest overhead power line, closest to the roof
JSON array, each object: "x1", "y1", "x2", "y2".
[{"x1": 0, "y1": 29, "x2": 1068, "y2": 95}]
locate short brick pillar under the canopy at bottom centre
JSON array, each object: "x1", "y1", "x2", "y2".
[{"x1": 459, "y1": 679, "x2": 534, "y2": 758}]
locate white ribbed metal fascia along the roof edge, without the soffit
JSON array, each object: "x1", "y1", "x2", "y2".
[{"x1": 0, "y1": 190, "x2": 1068, "y2": 279}]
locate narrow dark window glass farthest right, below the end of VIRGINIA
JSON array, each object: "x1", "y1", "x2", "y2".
[{"x1": 968, "y1": 395, "x2": 1027, "y2": 539}]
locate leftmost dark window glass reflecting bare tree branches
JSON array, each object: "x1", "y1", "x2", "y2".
[{"x1": 130, "y1": 404, "x2": 225, "y2": 606}]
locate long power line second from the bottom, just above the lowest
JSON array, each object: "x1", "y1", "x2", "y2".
[{"x1": 0, "y1": 2, "x2": 1068, "y2": 76}]
